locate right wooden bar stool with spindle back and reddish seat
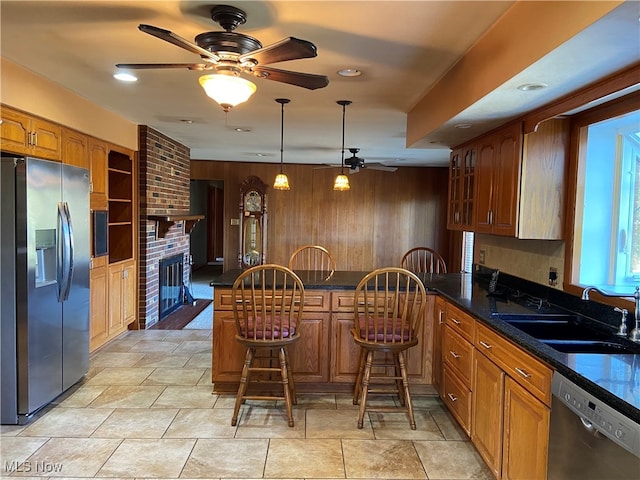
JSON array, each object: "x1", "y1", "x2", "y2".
[{"x1": 351, "y1": 267, "x2": 427, "y2": 430}]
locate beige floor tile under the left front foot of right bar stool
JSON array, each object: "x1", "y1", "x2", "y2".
[{"x1": 306, "y1": 409, "x2": 375, "y2": 440}]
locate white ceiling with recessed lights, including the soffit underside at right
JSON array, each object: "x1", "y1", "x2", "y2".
[{"x1": 0, "y1": 0, "x2": 640, "y2": 166}]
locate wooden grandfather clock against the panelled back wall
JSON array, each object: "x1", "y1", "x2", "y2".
[{"x1": 238, "y1": 176, "x2": 267, "y2": 269}]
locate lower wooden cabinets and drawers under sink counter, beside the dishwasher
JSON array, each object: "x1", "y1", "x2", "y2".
[{"x1": 434, "y1": 296, "x2": 553, "y2": 480}]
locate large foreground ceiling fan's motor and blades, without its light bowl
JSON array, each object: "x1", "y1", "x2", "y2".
[{"x1": 116, "y1": 5, "x2": 329, "y2": 90}]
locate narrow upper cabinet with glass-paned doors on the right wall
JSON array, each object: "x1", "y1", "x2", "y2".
[{"x1": 447, "y1": 144, "x2": 477, "y2": 230}]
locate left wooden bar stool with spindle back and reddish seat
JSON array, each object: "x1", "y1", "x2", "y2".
[{"x1": 231, "y1": 264, "x2": 304, "y2": 427}]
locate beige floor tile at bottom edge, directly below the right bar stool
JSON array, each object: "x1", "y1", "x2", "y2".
[{"x1": 342, "y1": 440, "x2": 427, "y2": 480}]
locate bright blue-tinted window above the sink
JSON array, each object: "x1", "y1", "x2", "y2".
[{"x1": 572, "y1": 108, "x2": 640, "y2": 294}]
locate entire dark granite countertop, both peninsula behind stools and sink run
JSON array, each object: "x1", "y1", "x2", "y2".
[{"x1": 210, "y1": 269, "x2": 640, "y2": 421}]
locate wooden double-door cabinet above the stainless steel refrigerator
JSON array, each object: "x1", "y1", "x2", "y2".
[{"x1": 0, "y1": 105, "x2": 62, "y2": 161}]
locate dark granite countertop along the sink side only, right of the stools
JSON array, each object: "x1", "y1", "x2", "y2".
[{"x1": 423, "y1": 274, "x2": 640, "y2": 422}]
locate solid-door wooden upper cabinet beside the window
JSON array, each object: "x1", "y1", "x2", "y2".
[{"x1": 473, "y1": 119, "x2": 569, "y2": 240}]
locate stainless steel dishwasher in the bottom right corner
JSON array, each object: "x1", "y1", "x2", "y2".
[{"x1": 548, "y1": 372, "x2": 640, "y2": 480}]
